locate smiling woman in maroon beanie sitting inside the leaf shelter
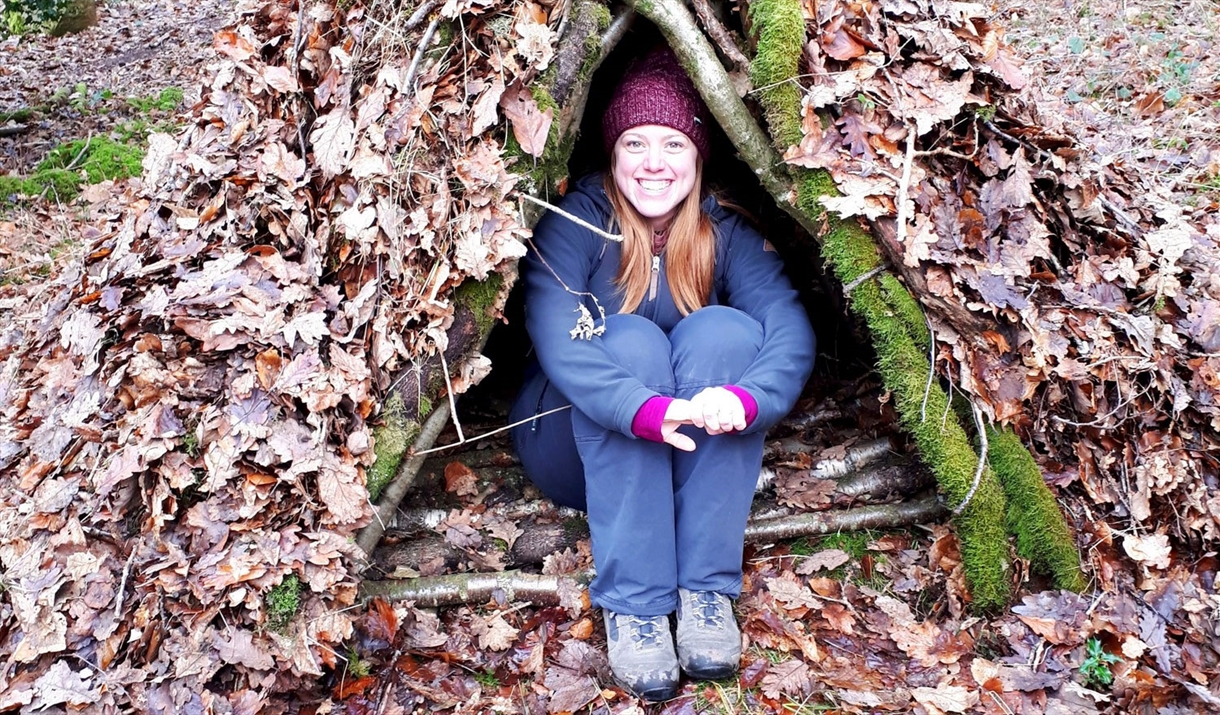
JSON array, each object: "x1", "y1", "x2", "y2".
[{"x1": 510, "y1": 49, "x2": 814, "y2": 700}]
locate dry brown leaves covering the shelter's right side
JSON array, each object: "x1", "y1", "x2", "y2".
[{"x1": 786, "y1": 0, "x2": 1220, "y2": 542}]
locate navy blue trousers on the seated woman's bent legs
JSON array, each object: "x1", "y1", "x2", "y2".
[{"x1": 511, "y1": 306, "x2": 765, "y2": 616}]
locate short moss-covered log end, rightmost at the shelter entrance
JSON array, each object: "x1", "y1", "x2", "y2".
[{"x1": 987, "y1": 427, "x2": 1088, "y2": 593}]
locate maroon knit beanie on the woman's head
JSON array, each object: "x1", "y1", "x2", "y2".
[{"x1": 601, "y1": 48, "x2": 710, "y2": 160}]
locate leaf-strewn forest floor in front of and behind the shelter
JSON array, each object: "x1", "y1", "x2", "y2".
[{"x1": 0, "y1": 0, "x2": 1220, "y2": 715}]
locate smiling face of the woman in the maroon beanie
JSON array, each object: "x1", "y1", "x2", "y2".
[{"x1": 614, "y1": 124, "x2": 699, "y2": 231}]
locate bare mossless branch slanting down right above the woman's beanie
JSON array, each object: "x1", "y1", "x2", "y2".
[{"x1": 627, "y1": 0, "x2": 822, "y2": 238}]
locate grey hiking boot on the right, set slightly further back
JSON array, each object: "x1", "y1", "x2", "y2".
[{"x1": 678, "y1": 588, "x2": 742, "y2": 680}]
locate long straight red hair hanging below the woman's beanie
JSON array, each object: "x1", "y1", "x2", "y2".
[{"x1": 605, "y1": 153, "x2": 716, "y2": 315}]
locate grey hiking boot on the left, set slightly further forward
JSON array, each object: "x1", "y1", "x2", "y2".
[{"x1": 603, "y1": 609, "x2": 678, "y2": 702}]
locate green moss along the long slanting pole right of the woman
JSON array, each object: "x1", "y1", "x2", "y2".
[{"x1": 750, "y1": 0, "x2": 1009, "y2": 610}]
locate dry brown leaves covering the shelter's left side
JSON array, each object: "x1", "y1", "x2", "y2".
[{"x1": 0, "y1": 2, "x2": 541, "y2": 713}]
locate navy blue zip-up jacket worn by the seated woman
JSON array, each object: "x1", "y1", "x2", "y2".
[{"x1": 521, "y1": 174, "x2": 815, "y2": 436}]
